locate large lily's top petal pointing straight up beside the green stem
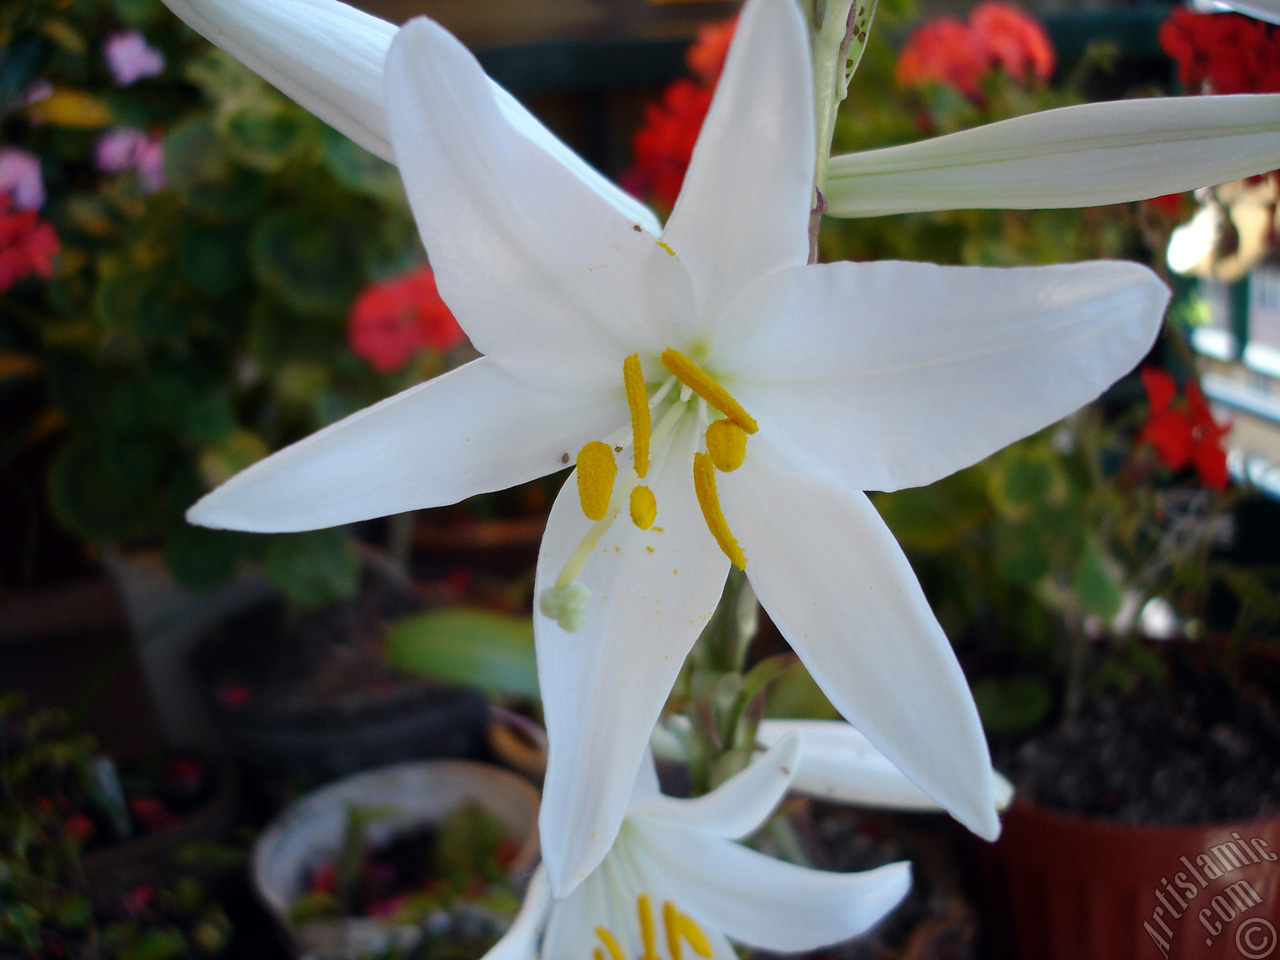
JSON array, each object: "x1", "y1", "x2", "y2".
[{"x1": 663, "y1": 0, "x2": 815, "y2": 321}]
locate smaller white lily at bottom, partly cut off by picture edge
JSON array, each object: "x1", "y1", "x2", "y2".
[{"x1": 485, "y1": 739, "x2": 911, "y2": 960}]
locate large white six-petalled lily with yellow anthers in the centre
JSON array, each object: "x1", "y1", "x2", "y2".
[{"x1": 180, "y1": 0, "x2": 1167, "y2": 896}]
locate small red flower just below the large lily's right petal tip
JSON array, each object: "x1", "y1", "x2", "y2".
[{"x1": 1138, "y1": 367, "x2": 1231, "y2": 490}]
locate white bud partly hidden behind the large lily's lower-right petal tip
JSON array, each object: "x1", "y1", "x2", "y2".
[{"x1": 756, "y1": 719, "x2": 1014, "y2": 810}]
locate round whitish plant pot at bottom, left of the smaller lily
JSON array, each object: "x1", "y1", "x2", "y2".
[{"x1": 250, "y1": 760, "x2": 539, "y2": 959}]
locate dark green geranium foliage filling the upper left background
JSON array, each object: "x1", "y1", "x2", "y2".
[{"x1": 0, "y1": 0, "x2": 422, "y2": 603}]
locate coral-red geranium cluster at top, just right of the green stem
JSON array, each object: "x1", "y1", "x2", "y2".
[{"x1": 893, "y1": 0, "x2": 1056, "y2": 100}]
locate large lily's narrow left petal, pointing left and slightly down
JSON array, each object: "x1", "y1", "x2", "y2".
[{"x1": 187, "y1": 357, "x2": 627, "y2": 532}]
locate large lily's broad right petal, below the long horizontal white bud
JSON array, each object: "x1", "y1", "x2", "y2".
[{"x1": 717, "y1": 261, "x2": 1169, "y2": 491}]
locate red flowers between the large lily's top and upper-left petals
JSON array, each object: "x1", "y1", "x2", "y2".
[{"x1": 622, "y1": 17, "x2": 737, "y2": 209}]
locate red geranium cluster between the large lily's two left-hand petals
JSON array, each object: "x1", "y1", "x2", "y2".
[{"x1": 347, "y1": 266, "x2": 465, "y2": 374}]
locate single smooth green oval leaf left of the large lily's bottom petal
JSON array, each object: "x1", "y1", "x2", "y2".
[{"x1": 387, "y1": 607, "x2": 538, "y2": 700}]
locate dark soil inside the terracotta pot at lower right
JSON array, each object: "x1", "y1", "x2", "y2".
[{"x1": 993, "y1": 644, "x2": 1280, "y2": 824}]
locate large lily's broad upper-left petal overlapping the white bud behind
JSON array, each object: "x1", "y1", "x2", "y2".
[{"x1": 387, "y1": 18, "x2": 691, "y2": 396}]
